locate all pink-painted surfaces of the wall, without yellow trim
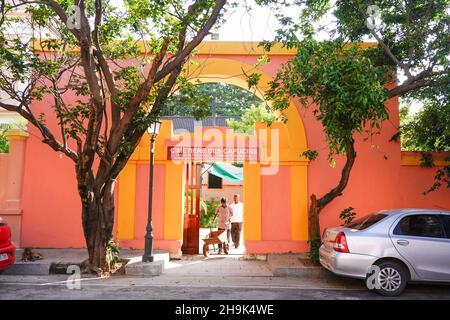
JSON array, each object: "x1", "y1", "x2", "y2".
[{"x1": 14, "y1": 51, "x2": 450, "y2": 252}]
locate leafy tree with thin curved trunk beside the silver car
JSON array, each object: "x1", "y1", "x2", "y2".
[{"x1": 256, "y1": 0, "x2": 450, "y2": 262}]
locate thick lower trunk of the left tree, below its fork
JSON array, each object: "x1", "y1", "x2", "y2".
[{"x1": 82, "y1": 181, "x2": 114, "y2": 274}]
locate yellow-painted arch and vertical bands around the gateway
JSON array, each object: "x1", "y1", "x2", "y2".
[{"x1": 119, "y1": 53, "x2": 308, "y2": 249}]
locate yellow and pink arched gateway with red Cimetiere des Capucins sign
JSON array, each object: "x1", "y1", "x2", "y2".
[{"x1": 116, "y1": 52, "x2": 308, "y2": 255}]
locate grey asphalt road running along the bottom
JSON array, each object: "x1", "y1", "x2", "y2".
[{"x1": 0, "y1": 275, "x2": 450, "y2": 301}]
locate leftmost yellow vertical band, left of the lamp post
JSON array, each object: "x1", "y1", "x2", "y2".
[{"x1": 117, "y1": 162, "x2": 136, "y2": 240}]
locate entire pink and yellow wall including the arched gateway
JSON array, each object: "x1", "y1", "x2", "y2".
[{"x1": 0, "y1": 42, "x2": 450, "y2": 255}]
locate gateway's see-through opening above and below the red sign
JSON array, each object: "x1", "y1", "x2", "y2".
[{"x1": 163, "y1": 82, "x2": 278, "y2": 254}]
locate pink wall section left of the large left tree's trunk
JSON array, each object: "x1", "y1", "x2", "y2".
[{"x1": 21, "y1": 122, "x2": 85, "y2": 248}]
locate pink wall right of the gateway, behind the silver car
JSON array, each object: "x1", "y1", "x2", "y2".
[{"x1": 198, "y1": 55, "x2": 450, "y2": 229}]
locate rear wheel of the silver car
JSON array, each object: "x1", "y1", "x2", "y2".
[{"x1": 375, "y1": 261, "x2": 408, "y2": 297}]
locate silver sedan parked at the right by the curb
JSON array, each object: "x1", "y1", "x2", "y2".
[{"x1": 319, "y1": 209, "x2": 450, "y2": 297}]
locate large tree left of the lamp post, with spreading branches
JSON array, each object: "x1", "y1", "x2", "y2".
[{"x1": 0, "y1": 0, "x2": 226, "y2": 272}]
